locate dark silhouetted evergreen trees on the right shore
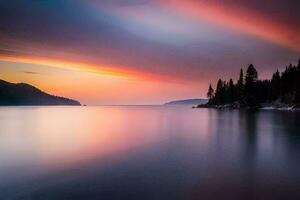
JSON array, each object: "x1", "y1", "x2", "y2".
[{"x1": 207, "y1": 60, "x2": 300, "y2": 106}]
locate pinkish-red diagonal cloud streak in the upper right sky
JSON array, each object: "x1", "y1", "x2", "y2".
[{"x1": 159, "y1": 0, "x2": 300, "y2": 52}]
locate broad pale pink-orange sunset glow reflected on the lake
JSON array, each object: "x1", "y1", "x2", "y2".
[{"x1": 0, "y1": 106, "x2": 211, "y2": 169}]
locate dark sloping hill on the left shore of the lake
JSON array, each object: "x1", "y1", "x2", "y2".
[{"x1": 0, "y1": 79, "x2": 81, "y2": 106}]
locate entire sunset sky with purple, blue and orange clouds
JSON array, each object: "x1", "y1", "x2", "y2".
[{"x1": 0, "y1": 0, "x2": 300, "y2": 105}]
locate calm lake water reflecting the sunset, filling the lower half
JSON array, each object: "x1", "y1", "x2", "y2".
[{"x1": 0, "y1": 106, "x2": 300, "y2": 200}]
